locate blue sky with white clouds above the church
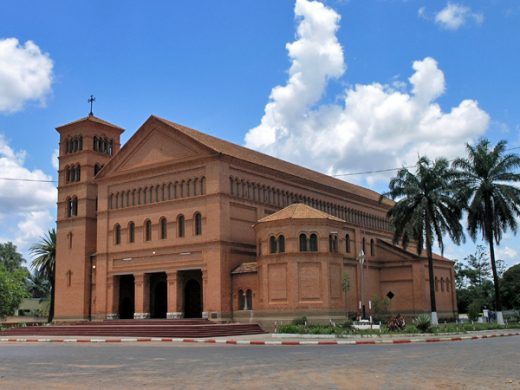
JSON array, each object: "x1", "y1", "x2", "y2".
[{"x1": 0, "y1": 0, "x2": 520, "y2": 264}]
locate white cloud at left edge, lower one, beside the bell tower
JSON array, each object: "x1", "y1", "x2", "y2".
[{"x1": 0, "y1": 134, "x2": 57, "y2": 251}]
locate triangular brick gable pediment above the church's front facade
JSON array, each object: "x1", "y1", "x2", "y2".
[{"x1": 97, "y1": 117, "x2": 217, "y2": 178}]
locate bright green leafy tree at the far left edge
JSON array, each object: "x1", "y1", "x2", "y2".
[{"x1": 0, "y1": 263, "x2": 27, "y2": 318}]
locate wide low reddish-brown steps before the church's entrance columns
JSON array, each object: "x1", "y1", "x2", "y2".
[{"x1": 0, "y1": 319, "x2": 265, "y2": 338}]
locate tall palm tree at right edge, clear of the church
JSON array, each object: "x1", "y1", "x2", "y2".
[{"x1": 453, "y1": 139, "x2": 520, "y2": 324}]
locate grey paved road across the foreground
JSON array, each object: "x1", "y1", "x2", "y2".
[{"x1": 0, "y1": 337, "x2": 520, "y2": 390}]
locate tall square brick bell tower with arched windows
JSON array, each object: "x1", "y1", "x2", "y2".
[{"x1": 54, "y1": 112, "x2": 124, "y2": 321}]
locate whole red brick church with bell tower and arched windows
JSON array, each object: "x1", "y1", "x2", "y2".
[{"x1": 55, "y1": 115, "x2": 457, "y2": 324}]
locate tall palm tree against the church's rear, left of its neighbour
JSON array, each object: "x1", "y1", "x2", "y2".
[{"x1": 381, "y1": 157, "x2": 464, "y2": 325}]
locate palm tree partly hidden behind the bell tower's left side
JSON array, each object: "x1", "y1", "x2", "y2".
[{"x1": 29, "y1": 229, "x2": 56, "y2": 322}]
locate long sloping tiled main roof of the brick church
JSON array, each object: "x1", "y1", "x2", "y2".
[{"x1": 151, "y1": 115, "x2": 390, "y2": 204}]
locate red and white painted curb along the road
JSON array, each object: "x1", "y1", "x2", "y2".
[{"x1": 0, "y1": 332, "x2": 520, "y2": 346}]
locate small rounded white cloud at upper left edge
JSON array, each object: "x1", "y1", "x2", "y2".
[{"x1": 0, "y1": 38, "x2": 53, "y2": 112}]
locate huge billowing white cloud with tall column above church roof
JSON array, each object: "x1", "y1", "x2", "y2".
[{"x1": 245, "y1": 0, "x2": 490, "y2": 185}]
